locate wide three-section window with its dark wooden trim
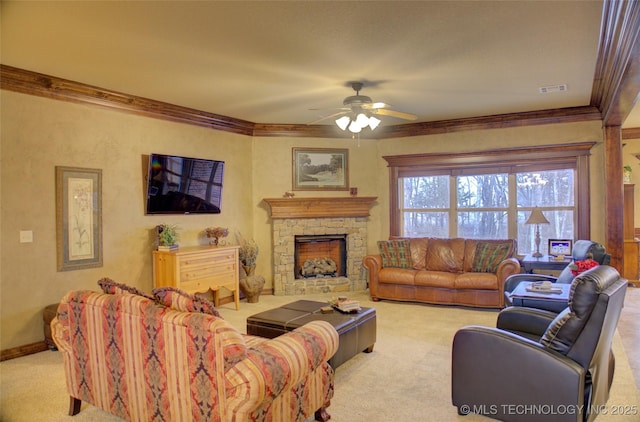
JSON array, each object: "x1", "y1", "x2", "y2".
[{"x1": 384, "y1": 144, "x2": 593, "y2": 254}]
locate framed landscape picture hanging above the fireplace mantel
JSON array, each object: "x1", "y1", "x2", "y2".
[{"x1": 293, "y1": 148, "x2": 349, "y2": 190}]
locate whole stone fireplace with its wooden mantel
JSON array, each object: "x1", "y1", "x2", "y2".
[{"x1": 264, "y1": 197, "x2": 376, "y2": 295}]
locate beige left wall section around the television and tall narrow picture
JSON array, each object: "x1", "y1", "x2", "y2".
[{"x1": 0, "y1": 91, "x2": 253, "y2": 350}]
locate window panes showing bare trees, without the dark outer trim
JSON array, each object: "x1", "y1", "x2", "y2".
[{"x1": 400, "y1": 169, "x2": 575, "y2": 254}]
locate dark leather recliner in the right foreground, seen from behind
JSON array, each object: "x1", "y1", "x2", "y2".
[{"x1": 451, "y1": 265, "x2": 627, "y2": 422}]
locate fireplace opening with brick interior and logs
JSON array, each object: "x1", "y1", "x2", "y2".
[{"x1": 294, "y1": 234, "x2": 347, "y2": 278}]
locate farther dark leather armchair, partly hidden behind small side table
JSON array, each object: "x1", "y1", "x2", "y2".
[{"x1": 504, "y1": 240, "x2": 611, "y2": 307}]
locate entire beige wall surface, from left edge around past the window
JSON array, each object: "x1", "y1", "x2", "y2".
[{"x1": 0, "y1": 91, "x2": 608, "y2": 350}]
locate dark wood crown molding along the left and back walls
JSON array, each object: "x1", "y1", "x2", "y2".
[{"x1": 0, "y1": 64, "x2": 601, "y2": 139}]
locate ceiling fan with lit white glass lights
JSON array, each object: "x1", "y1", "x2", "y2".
[{"x1": 310, "y1": 82, "x2": 417, "y2": 133}]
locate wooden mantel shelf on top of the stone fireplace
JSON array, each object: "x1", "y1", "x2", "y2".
[{"x1": 264, "y1": 196, "x2": 378, "y2": 218}]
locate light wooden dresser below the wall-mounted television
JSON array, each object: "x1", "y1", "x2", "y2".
[{"x1": 153, "y1": 246, "x2": 240, "y2": 309}]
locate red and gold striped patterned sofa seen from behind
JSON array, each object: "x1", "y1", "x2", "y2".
[{"x1": 51, "y1": 279, "x2": 338, "y2": 422}]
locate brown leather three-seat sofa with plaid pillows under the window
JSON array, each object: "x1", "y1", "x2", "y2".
[{"x1": 362, "y1": 237, "x2": 520, "y2": 308}]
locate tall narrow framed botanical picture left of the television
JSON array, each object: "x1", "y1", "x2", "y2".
[{"x1": 56, "y1": 166, "x2": 102, "y2": 271}]
